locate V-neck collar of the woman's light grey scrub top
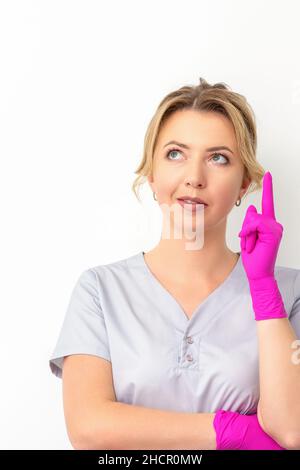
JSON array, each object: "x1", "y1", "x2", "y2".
[{"x1": 132, "y1": 251, "x2": 245, "y2": 327}]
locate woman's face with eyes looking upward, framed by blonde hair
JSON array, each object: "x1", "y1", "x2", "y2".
[{"x1": 148, "y1": 110, "x2": 250, "y2": 228}]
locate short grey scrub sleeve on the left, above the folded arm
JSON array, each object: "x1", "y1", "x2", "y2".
[{"x1": 49, "y1": 268, "x2": 111, "y2": 378}]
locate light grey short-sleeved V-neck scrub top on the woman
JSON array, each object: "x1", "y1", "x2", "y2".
[{"x1": 49, "y1": 252, "x2": 300, "y2": 414}]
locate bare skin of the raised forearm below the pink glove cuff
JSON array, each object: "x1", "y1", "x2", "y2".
[{"x1": 257, "y1": 318, "x2": 300, "y2": 450}]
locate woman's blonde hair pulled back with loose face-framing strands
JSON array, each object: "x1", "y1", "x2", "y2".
[{"x1": 132, "y1": 77, "x2": 265, "y2": 201}]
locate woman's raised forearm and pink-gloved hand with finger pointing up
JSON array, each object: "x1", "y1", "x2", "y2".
[{"x1": 239, "y1": 171, "x2": 300, "y2": 449}]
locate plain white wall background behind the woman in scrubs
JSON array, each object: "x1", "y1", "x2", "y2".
[{"x1": 0, "y1": 0, "x2": 300, "y2": 449}]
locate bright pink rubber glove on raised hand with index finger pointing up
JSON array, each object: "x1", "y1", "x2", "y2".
[{"x1": 239, "y1": 171, "x2": 287, "y2": 320}]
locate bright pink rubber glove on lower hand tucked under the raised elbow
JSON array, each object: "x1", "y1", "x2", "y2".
[{"x1": 213, "y1": 410, "x2": 286, "y2": 450}]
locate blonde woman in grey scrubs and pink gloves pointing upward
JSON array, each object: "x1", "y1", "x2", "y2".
[{"x1": 50, "y1": 78, "x2": 300, "y2": 449}]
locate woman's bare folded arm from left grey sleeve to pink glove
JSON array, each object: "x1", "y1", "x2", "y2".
[{"x1": 62, "y1": 354, "x2": 216, "y2": 450}]
